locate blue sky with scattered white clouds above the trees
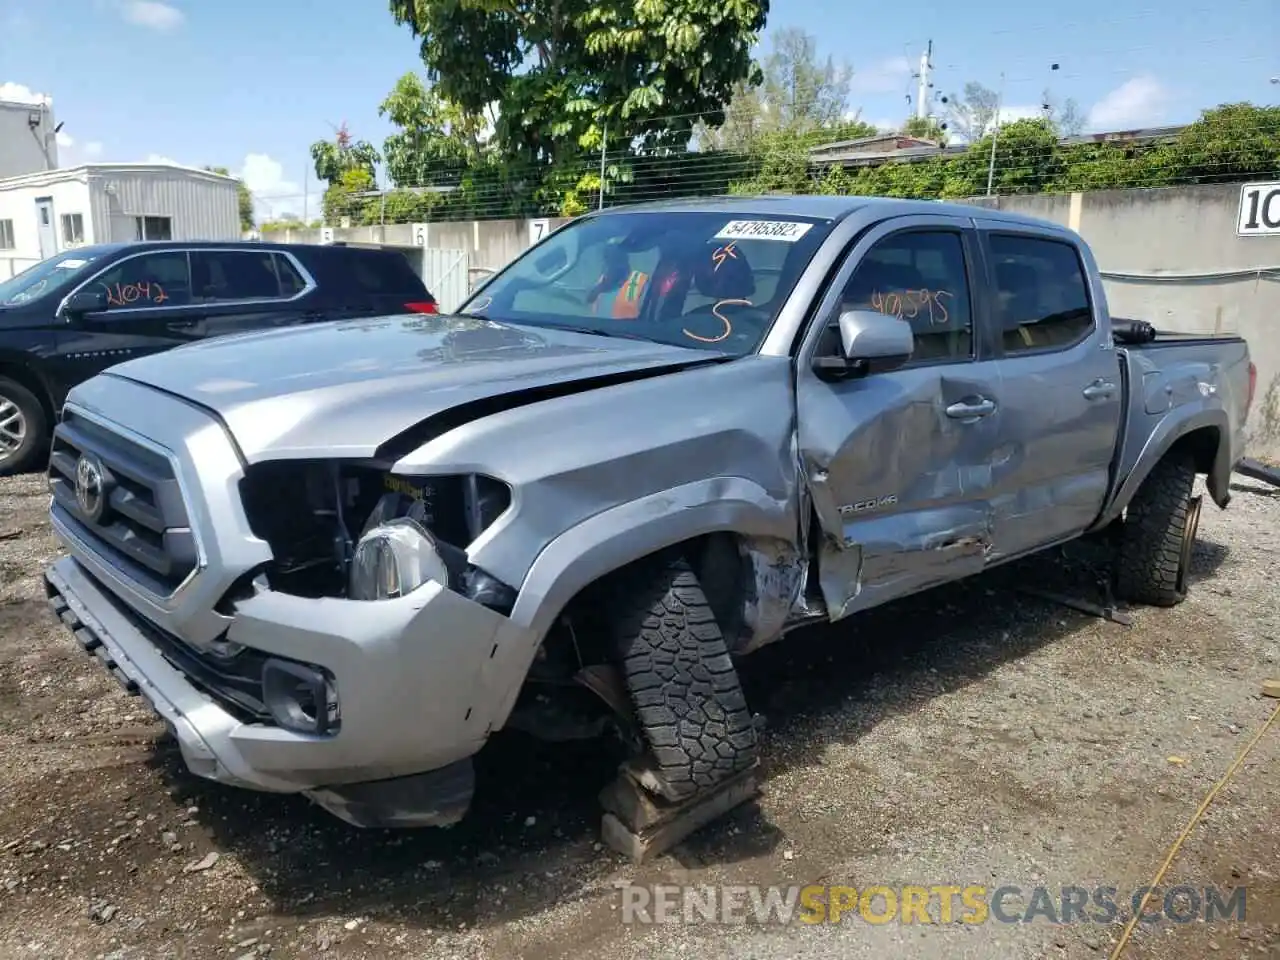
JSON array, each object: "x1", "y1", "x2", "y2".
[{"x1": 0, "y1": 0, "x2": 1280, "y2": 215}]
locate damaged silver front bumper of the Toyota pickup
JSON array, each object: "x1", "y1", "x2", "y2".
[{"x1": 45, "y1": 557, "x2": 522, "y2": 826}]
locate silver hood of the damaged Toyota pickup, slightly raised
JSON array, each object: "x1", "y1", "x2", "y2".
[{"x1": 108, "y1": 316, "x2": 719, "y2": 462}]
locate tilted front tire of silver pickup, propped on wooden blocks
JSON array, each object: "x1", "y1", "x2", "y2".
[{"x1": 608, "y1": 559, "x2": 756, "y2": 801}]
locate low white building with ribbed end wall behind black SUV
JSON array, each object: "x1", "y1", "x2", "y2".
[{"x1": 0, "y1": 164, "x2": 241, "y2": 280}]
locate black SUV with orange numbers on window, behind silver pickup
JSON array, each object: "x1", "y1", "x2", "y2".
[{"x1": 0, "y1": 241, "x2": 435, "y2": 476}]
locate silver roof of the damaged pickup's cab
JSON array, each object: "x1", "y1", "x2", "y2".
[{"x1": 591, "y1": 193, "x2": 1047, "y2": 227}]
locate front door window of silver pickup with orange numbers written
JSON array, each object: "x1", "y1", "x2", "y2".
[{"x1": 820, "y1": 230, "x2": 973, "y2": 364}]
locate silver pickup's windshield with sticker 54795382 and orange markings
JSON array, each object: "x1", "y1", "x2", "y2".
[{"x1": 461, "y1": 211, "x2": 831, "y2": 356}]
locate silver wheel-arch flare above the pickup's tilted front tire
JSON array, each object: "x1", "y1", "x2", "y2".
[{"x1": 483, "y1": 476, "x2": 799, "y2": 728}]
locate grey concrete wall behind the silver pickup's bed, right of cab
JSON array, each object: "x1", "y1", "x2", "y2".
[{"x1": 972, "y1": 183, "x2": 1280, "y2": 457}]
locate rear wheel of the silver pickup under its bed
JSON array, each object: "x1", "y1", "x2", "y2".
[{"x1": 1115, "y1": 454, "x2": 1201, "y2": 607}]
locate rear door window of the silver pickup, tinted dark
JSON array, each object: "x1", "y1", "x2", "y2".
[{"x1": 989, "y1": 233, "x2": 1093, "y2": 353}]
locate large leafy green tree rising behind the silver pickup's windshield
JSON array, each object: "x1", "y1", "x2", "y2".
[{"x1": 389, "y1": 0, "x2": 768, "y2": 168}]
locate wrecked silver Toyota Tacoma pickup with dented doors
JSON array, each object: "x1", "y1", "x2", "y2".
[{"x1": 46, "y1": 197, "x2": 1254, "y2": 826}]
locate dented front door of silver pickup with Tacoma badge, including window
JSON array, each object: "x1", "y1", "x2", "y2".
[{"x1": 796, "y1": 216, "x2": 1002, "y2": 618}]
